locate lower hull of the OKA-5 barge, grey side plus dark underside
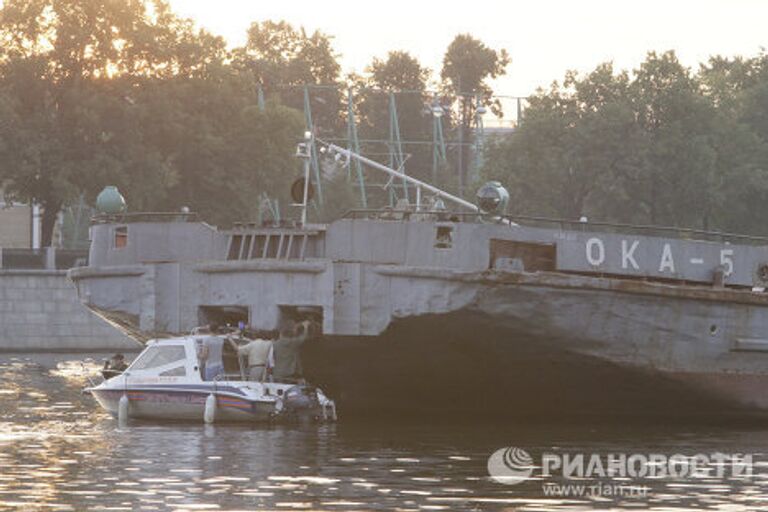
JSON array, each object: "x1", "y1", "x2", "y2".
[{"x1": 305, "y1": 274, "x2": 768, "y2": 419}]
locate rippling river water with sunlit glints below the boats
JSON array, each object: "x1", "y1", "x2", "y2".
[{"x1": 0, "y1": 354, "x2": 768, "y2": 511}]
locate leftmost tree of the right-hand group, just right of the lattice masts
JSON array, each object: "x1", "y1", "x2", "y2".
[{"x1": 484, "y1": 64, "x2": 641, "y2": 221}]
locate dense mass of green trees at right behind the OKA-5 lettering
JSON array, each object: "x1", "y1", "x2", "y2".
[{"x1": 484, "y1": 52, "x2": 768, "y2": 234}]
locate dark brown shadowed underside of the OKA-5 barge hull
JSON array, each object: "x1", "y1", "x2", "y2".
[{"x1": 304, "y1": 315, "x2": 768, "y2": 419}]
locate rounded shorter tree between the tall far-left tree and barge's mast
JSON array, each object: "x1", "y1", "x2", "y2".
[{"x1": 97, "y1": 68, "x2": 303, "y2": 225}]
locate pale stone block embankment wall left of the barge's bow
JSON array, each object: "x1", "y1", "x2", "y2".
[{"x1": 0, "y1": 269, "x2": 140, "y2": 352}]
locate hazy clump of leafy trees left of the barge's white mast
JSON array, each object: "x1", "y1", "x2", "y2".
[{"x1": 0, "y1": 0, "x2": 310, "y2": 245}]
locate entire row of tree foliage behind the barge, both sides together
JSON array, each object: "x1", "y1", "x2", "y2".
[{"x1": 6, "y1": 0, "x2": 768, "y2": 244}]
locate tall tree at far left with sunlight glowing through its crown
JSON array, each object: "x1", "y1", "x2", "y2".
[{"x1": 0, "y1": 0, "x2": 224, "y2": 245}]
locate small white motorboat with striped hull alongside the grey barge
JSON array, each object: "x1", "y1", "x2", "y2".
[{"x1": 86, "y1": 334, "x2": 336, "y2": 423}]
